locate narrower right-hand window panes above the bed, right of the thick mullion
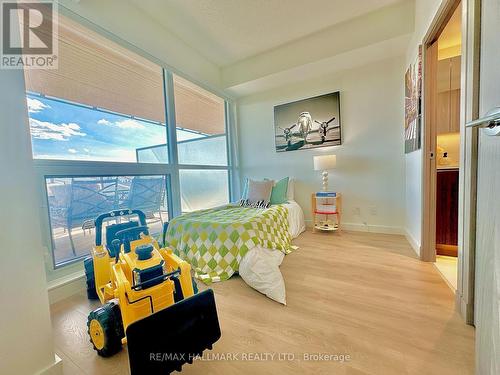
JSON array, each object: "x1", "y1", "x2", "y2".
[{"x1": 173, "y1": 76, "x2": 230, "y2": 212}]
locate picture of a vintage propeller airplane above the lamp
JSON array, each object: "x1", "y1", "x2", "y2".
[{"x1": 274, "y1": 91, "x2": 342, "y2": 152}]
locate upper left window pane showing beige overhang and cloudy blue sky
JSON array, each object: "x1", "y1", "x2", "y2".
[{"x1": 25, "y1": 16, "x2": 168, "y2": 163}]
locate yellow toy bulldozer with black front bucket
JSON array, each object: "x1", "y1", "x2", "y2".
[{"x1": 84, "y1": 210, "x2": 221, "y2": 374}]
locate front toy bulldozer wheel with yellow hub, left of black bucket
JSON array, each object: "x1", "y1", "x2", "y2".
[{"x1": 87, "y1": 302, "x2": 124, "y2": 357}]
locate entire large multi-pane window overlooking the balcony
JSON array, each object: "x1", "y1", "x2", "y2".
[{"x1": 25, "y1": 16, "x2": 232, "y2": 272}]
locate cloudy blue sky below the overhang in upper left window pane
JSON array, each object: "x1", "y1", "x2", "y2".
[{"x1": 27, "y1": 93, "x2": 168, "y2": 163}]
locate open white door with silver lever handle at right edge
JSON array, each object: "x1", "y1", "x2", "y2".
[{"x1": 467, "y1": 0, "x2": 500, "y2": 375}]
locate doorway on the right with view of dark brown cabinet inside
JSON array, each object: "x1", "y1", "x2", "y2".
[{"x1": 421, "y1": 1, "x2": 462, "y2": 293}]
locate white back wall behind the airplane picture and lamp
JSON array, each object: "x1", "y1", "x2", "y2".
[{"x1": 238, "y1": 58, "x2": 405, "y2": 233}]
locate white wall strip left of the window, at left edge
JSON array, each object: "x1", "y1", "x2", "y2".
[{"x1": 0, "y1": 69, "x2": 60, "y2": 375}]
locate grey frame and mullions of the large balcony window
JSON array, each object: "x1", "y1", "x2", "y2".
[{"x1": 30, "y1": 43, "x2": 240, "y2": 282}]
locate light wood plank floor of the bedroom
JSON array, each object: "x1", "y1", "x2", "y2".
[{"x1": 52, "y1": 232, "x2": 474, "y2": 375}]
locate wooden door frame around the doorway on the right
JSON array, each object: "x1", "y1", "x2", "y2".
[{"x1": 420, "y1": 0, "x2": 481, "y2": 324}]
